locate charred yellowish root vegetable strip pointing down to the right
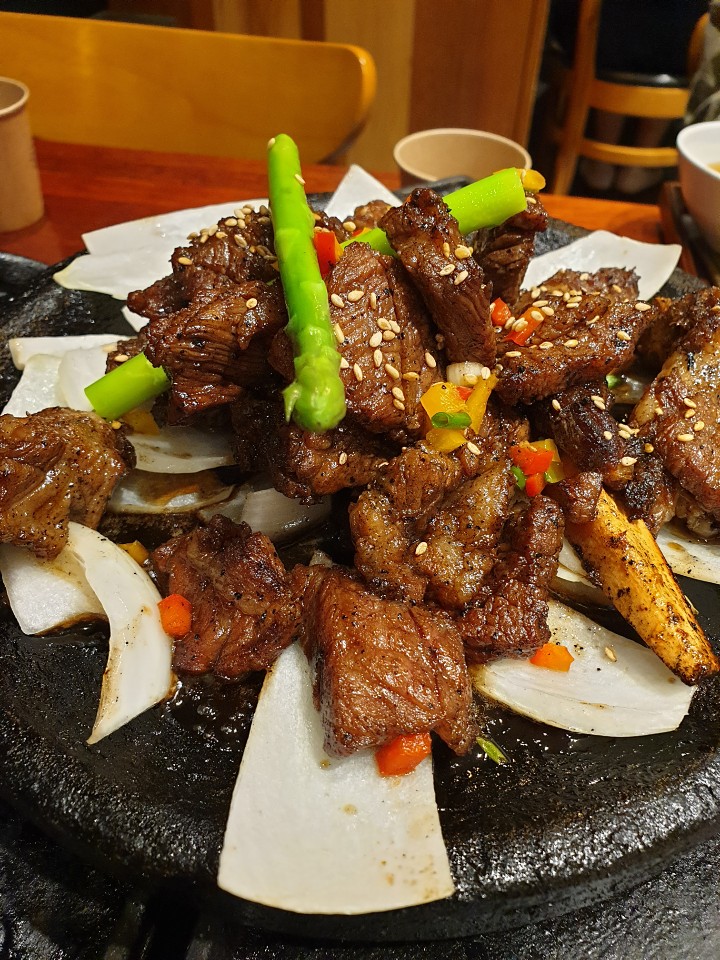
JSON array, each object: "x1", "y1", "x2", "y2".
[{"x1": 566, "y1": 491, "x2": 720, "y2": 684}]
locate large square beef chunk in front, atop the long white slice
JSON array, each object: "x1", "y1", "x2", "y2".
[{"x1": 302, "y1": 567, "x2": 476, "y2": 756}]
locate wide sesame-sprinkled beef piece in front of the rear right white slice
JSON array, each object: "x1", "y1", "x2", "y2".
[{"x1": 495, "y1": 269, "x2": 649, "y2": 404}]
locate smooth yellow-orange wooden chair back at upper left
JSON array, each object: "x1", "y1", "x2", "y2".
[{"x1": 0, "y1": 12, "x2": 376, "y2": 163}]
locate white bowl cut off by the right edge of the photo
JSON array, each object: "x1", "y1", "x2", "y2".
[{"x1": 677, "y1": 120, "x2": 720, "y2": 253}]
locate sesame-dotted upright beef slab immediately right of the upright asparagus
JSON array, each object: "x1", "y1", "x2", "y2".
[{"x1": 328, "y1": 243, "x2": 438, "y2": 441}]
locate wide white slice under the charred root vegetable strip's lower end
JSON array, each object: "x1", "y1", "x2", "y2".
[{"x1": 470, "y1": 601, "x2": 694, "y2": 737}]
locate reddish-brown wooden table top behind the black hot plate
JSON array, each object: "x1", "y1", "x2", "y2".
[{"x1": 0, "y1": 141, "x2": 661, "y2": 263}]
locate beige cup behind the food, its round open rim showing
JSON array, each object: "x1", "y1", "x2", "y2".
[{"x1": 393, "y1": 127, "x2": 532, "y2": 186}]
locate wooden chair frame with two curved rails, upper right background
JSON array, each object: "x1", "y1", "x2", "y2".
[{"x1": 550, "y1": 0, "x2": 707, "y2": 194}]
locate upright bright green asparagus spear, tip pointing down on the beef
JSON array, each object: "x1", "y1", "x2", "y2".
[{"x1": 268, "y1": 133, "x2": 345, "y2": 432}]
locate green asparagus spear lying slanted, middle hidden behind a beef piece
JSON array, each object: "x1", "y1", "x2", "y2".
[{"x1": 340, "y1": 167, "x2": 527, "y2": 256}]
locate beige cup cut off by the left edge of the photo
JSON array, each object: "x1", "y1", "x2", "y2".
[{"x1": 0, "y1": 77, "x2": 43, "y2": 232}]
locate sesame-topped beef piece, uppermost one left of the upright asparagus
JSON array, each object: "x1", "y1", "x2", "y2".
[{"x1": 127, "y1": 207, "x2": 277, "y2": 320}]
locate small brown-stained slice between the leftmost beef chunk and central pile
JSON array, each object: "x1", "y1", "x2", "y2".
[{"x1": 108, "y1": 470, "x2": 234, "y2": 513}]
